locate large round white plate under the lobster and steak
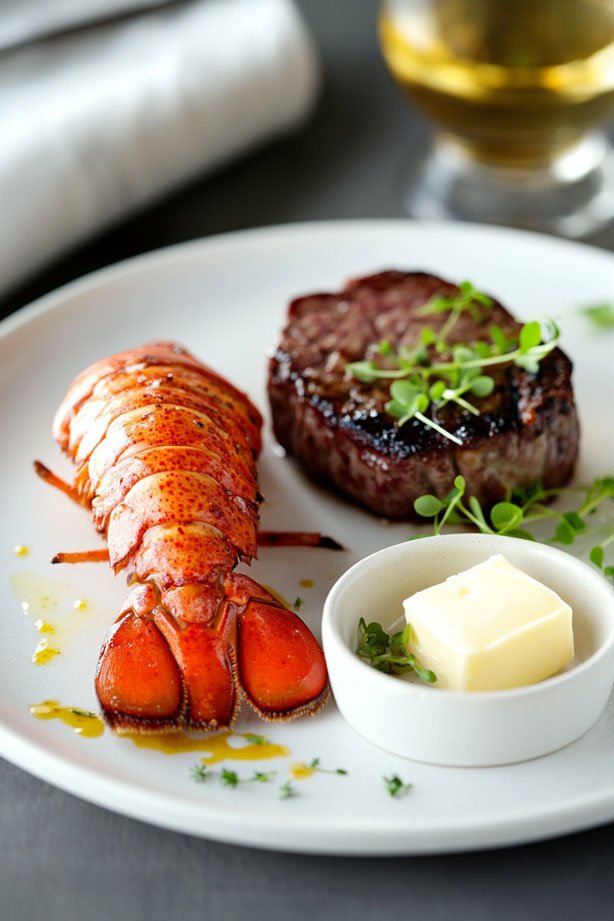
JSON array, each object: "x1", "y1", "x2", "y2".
[{"x1": 0, "y1": 221, "x2": 614, "y2": 854}]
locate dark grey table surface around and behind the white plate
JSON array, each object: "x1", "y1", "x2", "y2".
[{"x1": 0, "y1": 0, "x2": 614, "y2": 921}]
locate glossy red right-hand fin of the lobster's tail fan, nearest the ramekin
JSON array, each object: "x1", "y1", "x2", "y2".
[{"x1": 231, "y1": 576, "x2": 330, "y2": 720}]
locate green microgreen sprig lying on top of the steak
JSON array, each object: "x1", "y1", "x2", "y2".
[{"x1": 346, "y1": 281, "x2": 560, "y2": 445}]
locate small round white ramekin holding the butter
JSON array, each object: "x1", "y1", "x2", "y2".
[{"x1": 322, "y1": 534, "x2": 614, "y2": 767}]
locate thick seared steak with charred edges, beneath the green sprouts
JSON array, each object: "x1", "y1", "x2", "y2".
[{"x1": 268, "y1": 271, "x2": 579, "y2": 519}]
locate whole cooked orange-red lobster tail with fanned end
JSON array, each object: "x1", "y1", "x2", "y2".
[{"x1": 37, "y1": 342, "x2": 329, "y2": 733}]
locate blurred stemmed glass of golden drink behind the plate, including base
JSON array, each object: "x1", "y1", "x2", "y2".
[{"x1": 379, "y1": 0, "x2": 614, "y2": 237}]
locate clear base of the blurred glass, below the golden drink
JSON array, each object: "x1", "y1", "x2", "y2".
[{"x1": 405, "y1": 135, "x2": 614, "y2": 239}]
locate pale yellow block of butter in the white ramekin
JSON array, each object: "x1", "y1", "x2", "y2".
[{"x1": 403, "y1": 554, "x2": 574, "y2": 691}]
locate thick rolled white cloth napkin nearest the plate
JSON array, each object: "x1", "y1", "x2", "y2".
[{"x1": 0, "y1": 0, "x2": 319, "y2": 292}]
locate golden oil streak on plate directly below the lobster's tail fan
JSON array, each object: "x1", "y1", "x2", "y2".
[{"x1": 123, "y1": 731, "x2": 290, "y2": 764}]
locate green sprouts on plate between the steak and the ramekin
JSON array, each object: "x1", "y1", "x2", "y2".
[{"x1": 414, "y1": 476, "x2": 614, "y2": 578}]
